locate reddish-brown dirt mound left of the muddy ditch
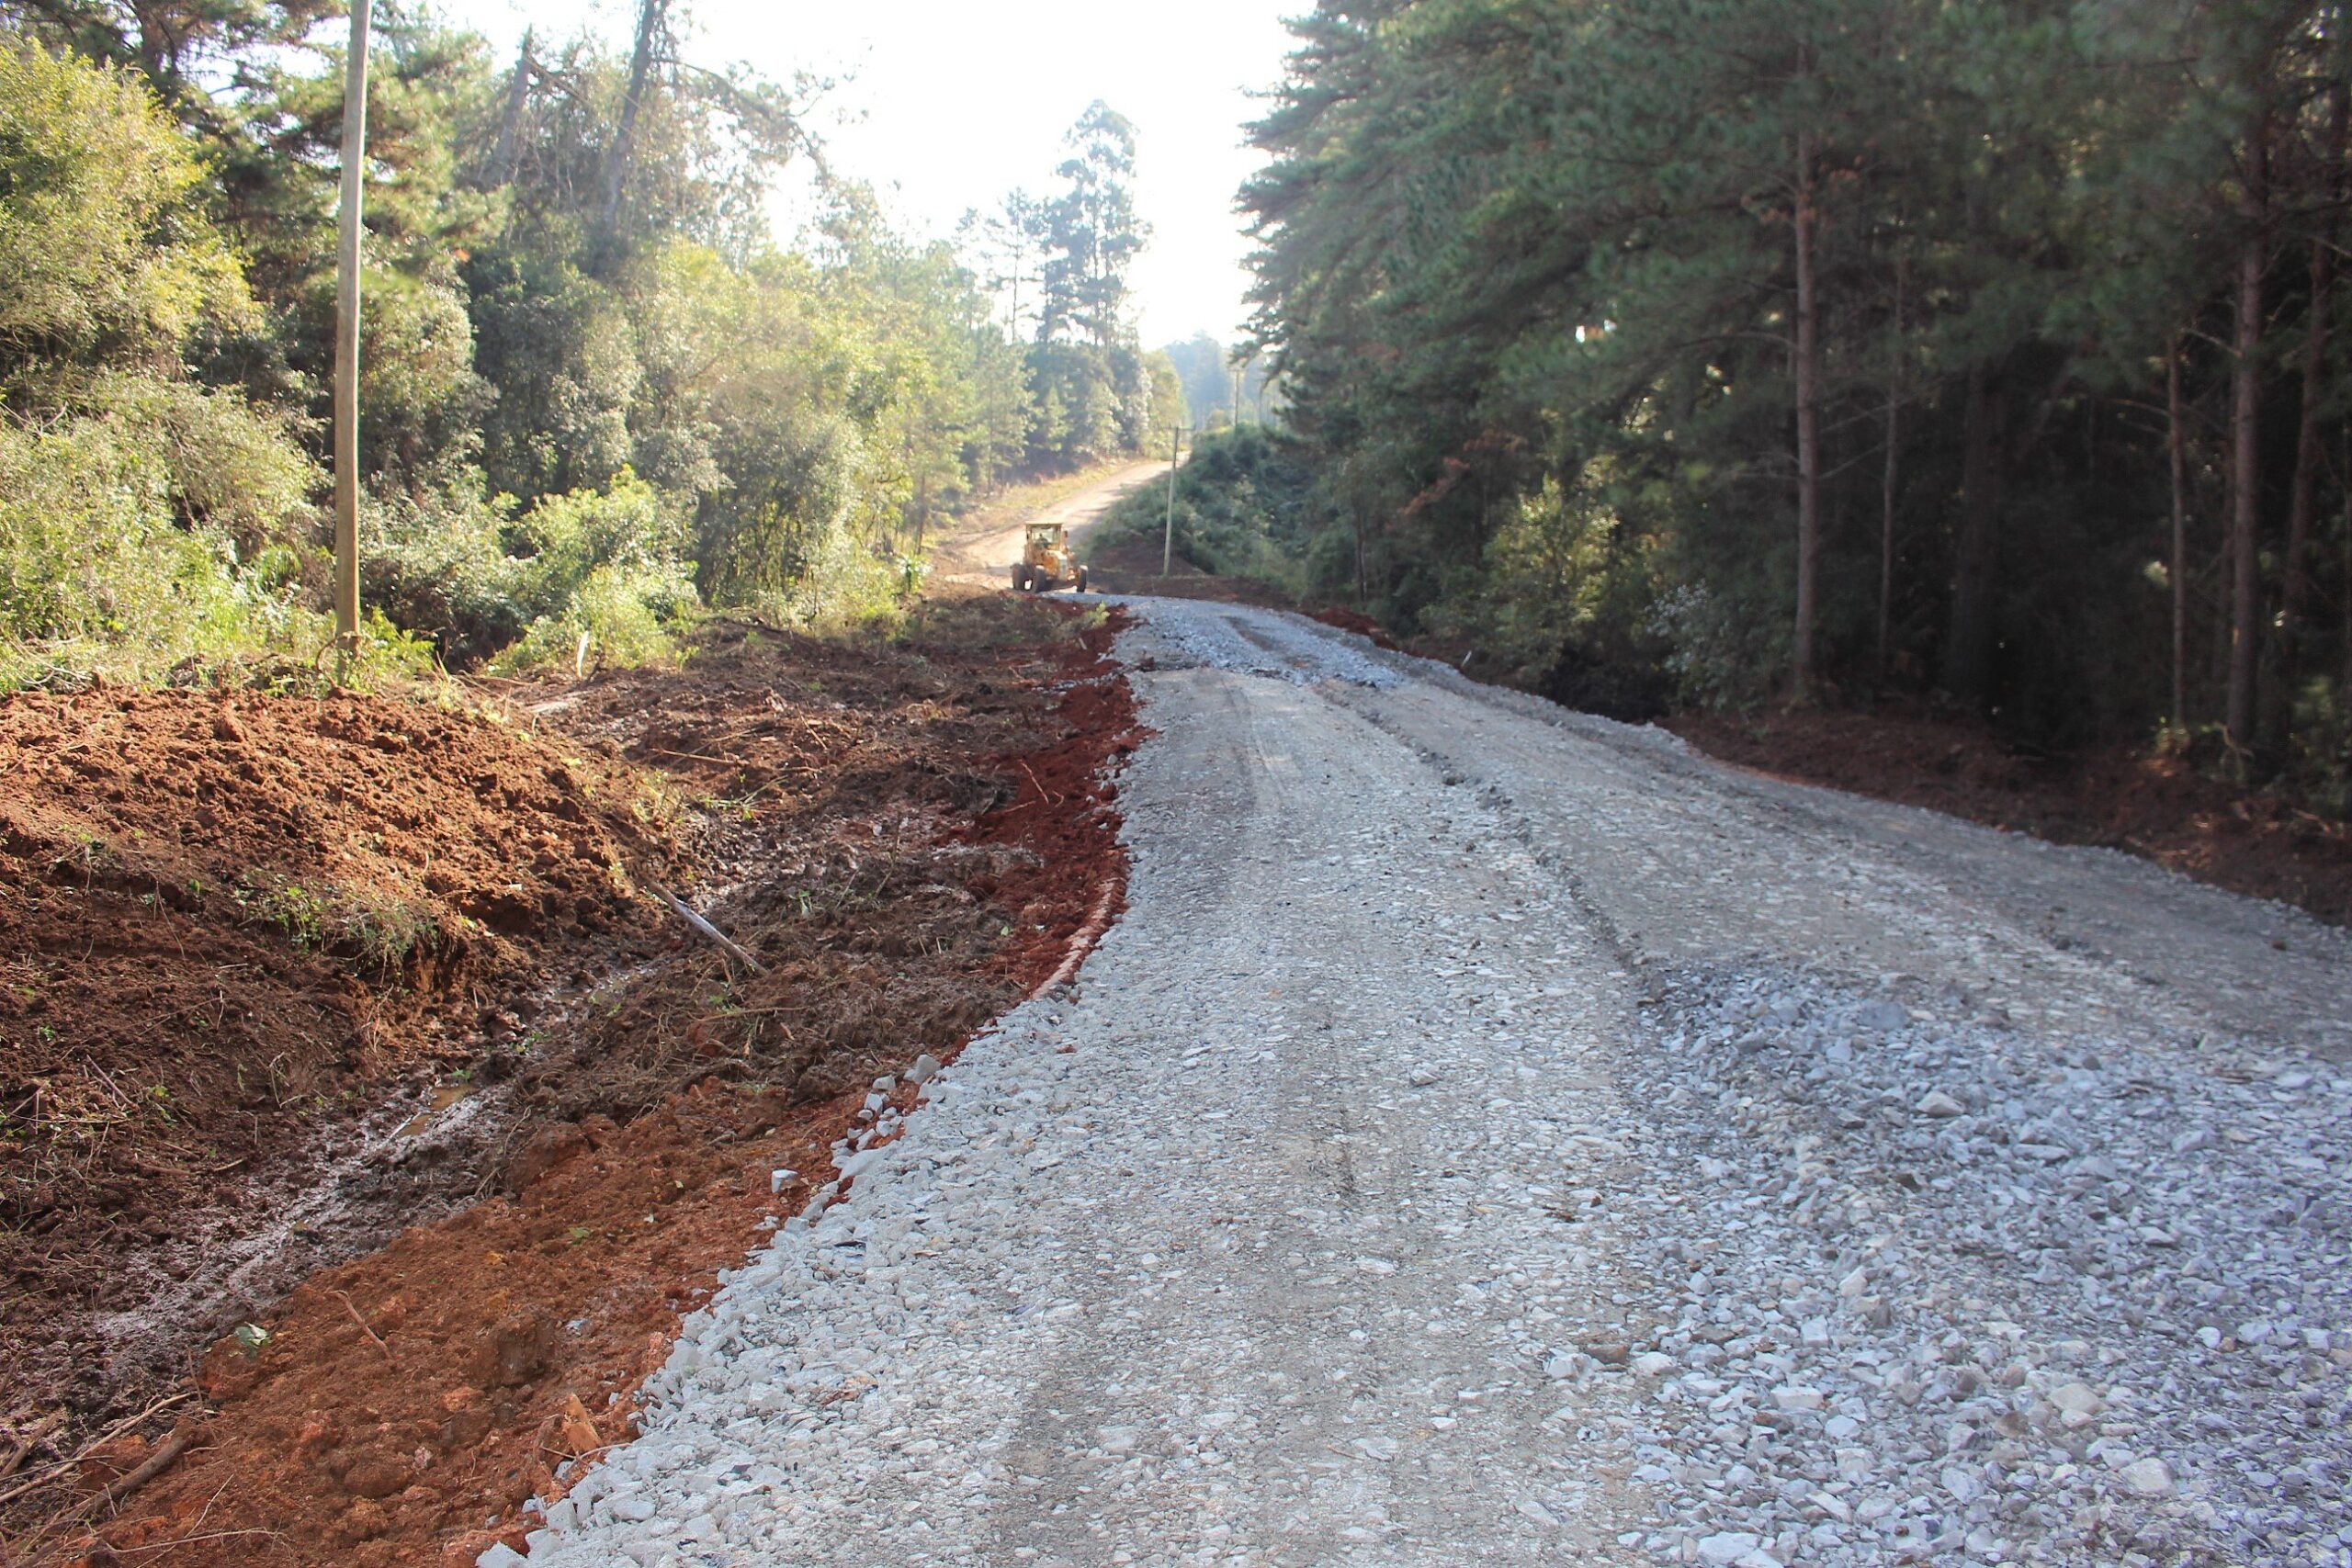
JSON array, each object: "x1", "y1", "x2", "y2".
[{"x1": 0, "y1": 691, "x2": 661, "y2": 1432}]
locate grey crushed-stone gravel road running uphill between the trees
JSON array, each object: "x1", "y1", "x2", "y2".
[{"x1": 514, "y1": 600, "x2": 2352, "y2": 1568}]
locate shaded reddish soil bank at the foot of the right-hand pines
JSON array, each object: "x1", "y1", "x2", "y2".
[{"x1": 1665, "y1": 712, "x2": 2352, "y2": 926}]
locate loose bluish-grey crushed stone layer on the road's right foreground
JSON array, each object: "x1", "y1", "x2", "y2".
[{"x1": 1604, "y1": 968, "x2": 2352, "y2": 1563}]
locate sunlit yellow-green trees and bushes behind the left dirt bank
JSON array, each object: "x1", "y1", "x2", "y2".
[{"x1": 0, "y1": 0, "x2": 1181, "y2": 686}]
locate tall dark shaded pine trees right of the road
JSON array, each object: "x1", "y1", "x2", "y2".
[{"x1": 1244, "y1": 0, "x2": 2352, "y2": 808}]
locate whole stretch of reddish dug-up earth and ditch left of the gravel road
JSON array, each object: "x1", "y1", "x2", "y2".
[{"x1": 0, "y1": 594, "x2": 1138, "y2": 1568}]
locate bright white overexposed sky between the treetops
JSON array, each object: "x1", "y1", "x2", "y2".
[{"x1": 484, "y1": 0, "x2": 1306, "y2": 348}]
